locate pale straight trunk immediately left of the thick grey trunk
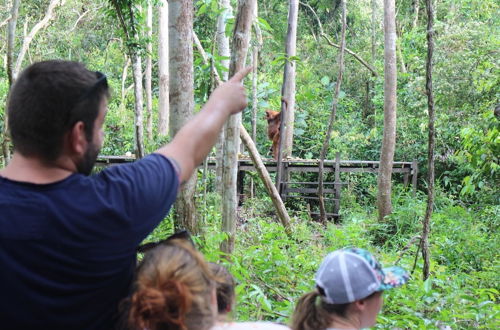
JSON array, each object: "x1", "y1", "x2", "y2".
[{"x1": 158, "y1": 0, "x2": 170, "y2": 136}]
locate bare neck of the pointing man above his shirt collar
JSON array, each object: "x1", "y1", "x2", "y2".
[{"x1": 0, "y1": 152, "x2": 76, "y2": 184}]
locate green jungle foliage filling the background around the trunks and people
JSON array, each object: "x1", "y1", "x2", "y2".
[{"x1": 0, "y1": 0, "x2": 500, "y2": 329}]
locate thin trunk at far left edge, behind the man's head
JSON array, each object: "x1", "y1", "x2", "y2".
[{"x1": 2, "y1": 0, "x2": 21, "y2": 165}]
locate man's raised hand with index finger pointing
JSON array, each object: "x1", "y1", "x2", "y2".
[{"x1": 207, "y1": 67, "x2": 252, "y2": 115}]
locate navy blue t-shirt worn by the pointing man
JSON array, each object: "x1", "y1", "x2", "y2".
[{"x1": 0, "y1": 154, "x2": 179, "y2": 329}]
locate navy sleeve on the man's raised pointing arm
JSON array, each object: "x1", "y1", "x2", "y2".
[{"x1": 95, "y1": 154, "x2": 179, "y2": 244}]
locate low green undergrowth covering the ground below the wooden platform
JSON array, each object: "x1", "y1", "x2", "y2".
[{"x1": 143, "y1": 184, "x2": 500, "y2": 329}]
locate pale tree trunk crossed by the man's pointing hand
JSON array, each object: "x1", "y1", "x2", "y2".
[{"x1": 221, "y1": 0, "x2": 256, "y2": 254}]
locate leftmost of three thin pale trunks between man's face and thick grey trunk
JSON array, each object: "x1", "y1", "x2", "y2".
[{"x1": 132, "y1": 54, "x2": 144, "y2": 159}]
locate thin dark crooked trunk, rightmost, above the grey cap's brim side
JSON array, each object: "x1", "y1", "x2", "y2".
[{"x1": 422, "y1": 0, "x2": 435, "y2": 281}]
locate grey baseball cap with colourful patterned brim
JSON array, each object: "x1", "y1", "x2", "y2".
[{"x1": 316, "y1": 248, "x2": 409, "y2": 304}]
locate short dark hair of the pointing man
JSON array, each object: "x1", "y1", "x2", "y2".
[{"x1": 7, "y1": 60, "x2": 109, "y2": 162}]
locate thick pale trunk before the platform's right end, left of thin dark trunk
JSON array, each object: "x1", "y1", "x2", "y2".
[{"x1": 377, "y1": 0, "x2": 397, "y2": 221}]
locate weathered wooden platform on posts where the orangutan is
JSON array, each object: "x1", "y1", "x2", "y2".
[{"x1": 96, "y1": 154, "x2": 418, "y2": 219}]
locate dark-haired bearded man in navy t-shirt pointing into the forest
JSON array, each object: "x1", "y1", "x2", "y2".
[{"x1": 0, "y1": 61, "x2": 249, "y2": 329}]
